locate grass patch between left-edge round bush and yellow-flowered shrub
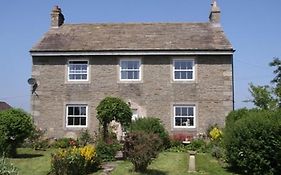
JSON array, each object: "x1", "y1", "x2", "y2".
[{"x1": 10, "y1": 148, "x2": 54, "y2": 175}]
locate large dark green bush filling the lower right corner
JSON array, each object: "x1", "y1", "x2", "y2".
[{"x1": 224, "y1": 110, "x2": 281, "y2": 174}]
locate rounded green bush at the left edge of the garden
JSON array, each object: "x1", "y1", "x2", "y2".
[{"x1": 0, "y1": 109, "x2": 34, "y2": 157}]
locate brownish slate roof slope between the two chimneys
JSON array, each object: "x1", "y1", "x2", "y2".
[{"x1": 31, "y1": 22, "x2": 233, "y2": 52}]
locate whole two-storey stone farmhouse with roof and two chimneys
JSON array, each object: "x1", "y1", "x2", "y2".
[{"x1": 30, "y1": 1, "x2": 234, "y2": 137}]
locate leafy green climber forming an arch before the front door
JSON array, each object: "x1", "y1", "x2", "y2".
[{"x1": 96, "y1": 97, "x2": 132, "y2": 141}]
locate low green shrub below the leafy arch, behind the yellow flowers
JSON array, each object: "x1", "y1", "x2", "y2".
[{"x1": 96, "y1": 140, "x2": 122, "y2": 162}]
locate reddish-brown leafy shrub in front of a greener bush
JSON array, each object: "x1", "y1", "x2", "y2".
[{"x1": 124, "y1": 131, "x2": 162, "y2": 172}]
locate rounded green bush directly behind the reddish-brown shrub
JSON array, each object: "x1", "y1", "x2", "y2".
[{"x1": 131, "y1": 117, "x2": 170, "y2": 148}]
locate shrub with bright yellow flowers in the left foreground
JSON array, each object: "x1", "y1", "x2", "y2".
[{"x1": 51, "y1": 145, "x2": 99, "y2": 175}]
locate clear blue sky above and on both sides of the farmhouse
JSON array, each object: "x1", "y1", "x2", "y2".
[{"x1": 0, "y1": 0, "x2": 281, "y2": 111}]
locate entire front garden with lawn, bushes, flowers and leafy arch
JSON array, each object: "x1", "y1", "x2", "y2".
[{"x1": 0, "y1": 97, "x2": 281, "y2": 175}]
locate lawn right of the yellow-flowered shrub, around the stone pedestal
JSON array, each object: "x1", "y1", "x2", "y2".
[{"x1": 93, "y1": 152, "x2": 234, "y2": 175}]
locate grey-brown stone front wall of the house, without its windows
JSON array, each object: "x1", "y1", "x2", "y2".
[{"x1": 31, "y1": 56, "x2": 233, "y2": 137}]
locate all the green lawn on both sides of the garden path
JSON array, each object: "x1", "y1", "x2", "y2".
[{"x1": 10, "y1": 148, "x2": 237, "y2": 175}]
